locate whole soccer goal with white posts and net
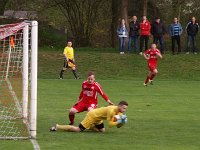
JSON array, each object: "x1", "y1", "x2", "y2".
[{"x1": 0, "y1": 21, "x2": 38, "y2": 139}]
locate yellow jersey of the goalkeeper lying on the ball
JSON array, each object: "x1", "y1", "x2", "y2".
[{"x1": 87, "y1": 106, "x2": 120, "y2": 127}]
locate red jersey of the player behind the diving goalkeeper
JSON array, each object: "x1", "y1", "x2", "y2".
[{"x1": 79, "y1": 81, "x2": 108, "y2": 104}]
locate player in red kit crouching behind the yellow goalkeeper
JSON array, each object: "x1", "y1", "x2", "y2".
[{"x1": 69, "y1": 72, "x2": 113, "y2": 125}]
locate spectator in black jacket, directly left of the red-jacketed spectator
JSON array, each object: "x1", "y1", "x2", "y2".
[{"x1": 128, "y1": 16, "x2": 140, "y2": 53}]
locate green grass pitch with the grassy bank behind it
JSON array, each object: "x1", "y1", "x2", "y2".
[{"x1": 0, "y1": 48, "x2": 200, "y2": 150}]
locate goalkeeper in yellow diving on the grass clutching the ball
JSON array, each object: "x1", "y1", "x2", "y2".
[{"x1": 50, "y1": 101, "x2": 128, "y2": 132}]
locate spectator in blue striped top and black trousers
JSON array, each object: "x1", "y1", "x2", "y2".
[{"x1": 169, "y1": 17, "x2": 183, "y2": 55}]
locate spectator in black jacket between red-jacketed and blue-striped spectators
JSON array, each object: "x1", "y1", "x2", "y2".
[{"x1": 151, "y1": 17, "x2": 166, "y2": 54}]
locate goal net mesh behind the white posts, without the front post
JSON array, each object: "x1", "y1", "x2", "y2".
[{"x1": 0, "y1": 22, "x2": 30, "y2": 139}]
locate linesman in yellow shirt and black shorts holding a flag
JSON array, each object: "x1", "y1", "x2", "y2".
[{"x1": 59, "y1": 41, "x2": 79, "y2": 79}]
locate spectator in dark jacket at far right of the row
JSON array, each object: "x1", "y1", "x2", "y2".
[{"x1": 186, "y1": 17, "x2": 199, "y2": 54}]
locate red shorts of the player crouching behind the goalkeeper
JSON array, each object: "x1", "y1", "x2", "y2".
[{"x1": 73, "y1": 101, "x2": 97, "y2": 112}]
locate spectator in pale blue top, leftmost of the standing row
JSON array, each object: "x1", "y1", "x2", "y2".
[{"x1": 117, "y1": 19, "x2": 128, "y2": 54}]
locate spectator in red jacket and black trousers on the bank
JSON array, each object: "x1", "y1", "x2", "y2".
[{"x1": 140, "y1": 16, "x2": 151, "y2": 55}]
